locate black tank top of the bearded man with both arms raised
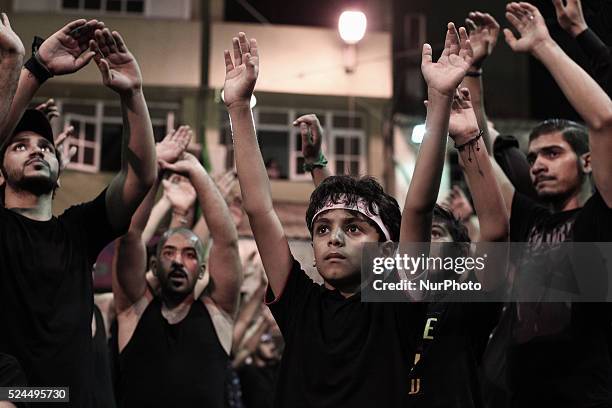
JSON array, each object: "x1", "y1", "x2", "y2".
[{"x1": 119, "y1": 297, "x2": 229, "y2": 408}]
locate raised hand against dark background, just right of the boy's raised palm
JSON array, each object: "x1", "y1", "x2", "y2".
[{"x1": 465, "y1": 11, "x2": 499, "y2": 68}]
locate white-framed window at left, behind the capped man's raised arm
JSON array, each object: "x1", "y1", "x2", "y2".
[{"x1": 57, "y1": 100, "x2": 178, "y2": 173}]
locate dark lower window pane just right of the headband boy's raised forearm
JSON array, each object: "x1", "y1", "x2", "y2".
[{"x1": 257, "y1": 130, "x2": 289, "y2": 179}]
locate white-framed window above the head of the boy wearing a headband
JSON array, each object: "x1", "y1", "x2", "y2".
[{"x1": 220, "y1": 107, "x2": 366, "y2": 180}]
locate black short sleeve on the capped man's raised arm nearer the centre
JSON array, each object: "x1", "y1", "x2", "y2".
[{"x1": 59, "y1": 189, "x2": 127, "y2": 264}]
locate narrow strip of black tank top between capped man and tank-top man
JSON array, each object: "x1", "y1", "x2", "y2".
[{"x1": 92, "y1": 304, "x2": 116, "y2": 408}]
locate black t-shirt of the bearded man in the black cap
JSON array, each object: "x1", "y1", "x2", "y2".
[{"x1": 0, "y1": 191, "x2": 120, "y2": 407}]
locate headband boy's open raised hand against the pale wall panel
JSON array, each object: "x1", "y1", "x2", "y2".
[{"x1": 223, "y1": 33, "x2": 259, "y2": 108}]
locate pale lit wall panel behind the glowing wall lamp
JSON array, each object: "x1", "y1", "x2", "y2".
[{"x1": 209, "y1": 22, "x2": 392, "y2": 98}]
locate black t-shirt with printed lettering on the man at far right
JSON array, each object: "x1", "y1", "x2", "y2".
[{"x1": 506, "y1": 193, "x2": 612, "y2": 407}]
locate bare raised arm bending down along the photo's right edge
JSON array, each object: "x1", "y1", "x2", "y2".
[{"x1": 504, "y1": 3, "x2": 612, "y2": 207}]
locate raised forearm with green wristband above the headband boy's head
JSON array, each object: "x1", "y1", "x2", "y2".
[{"x1": 293, "y1": 114, "x2": 332, "y2": 187}]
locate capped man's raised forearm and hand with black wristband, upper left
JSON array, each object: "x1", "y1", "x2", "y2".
[{"x1": 0, "y1": 19, "x2": 104, "y2": 140}]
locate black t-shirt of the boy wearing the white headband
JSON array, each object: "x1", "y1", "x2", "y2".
[{"x1": 266, "y1": 261, "x2": 427, "y2": 408}]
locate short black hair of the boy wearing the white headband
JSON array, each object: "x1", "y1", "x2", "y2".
[{"x1": 306, "y1": 176, "x2": 402, "y2": 242}]
